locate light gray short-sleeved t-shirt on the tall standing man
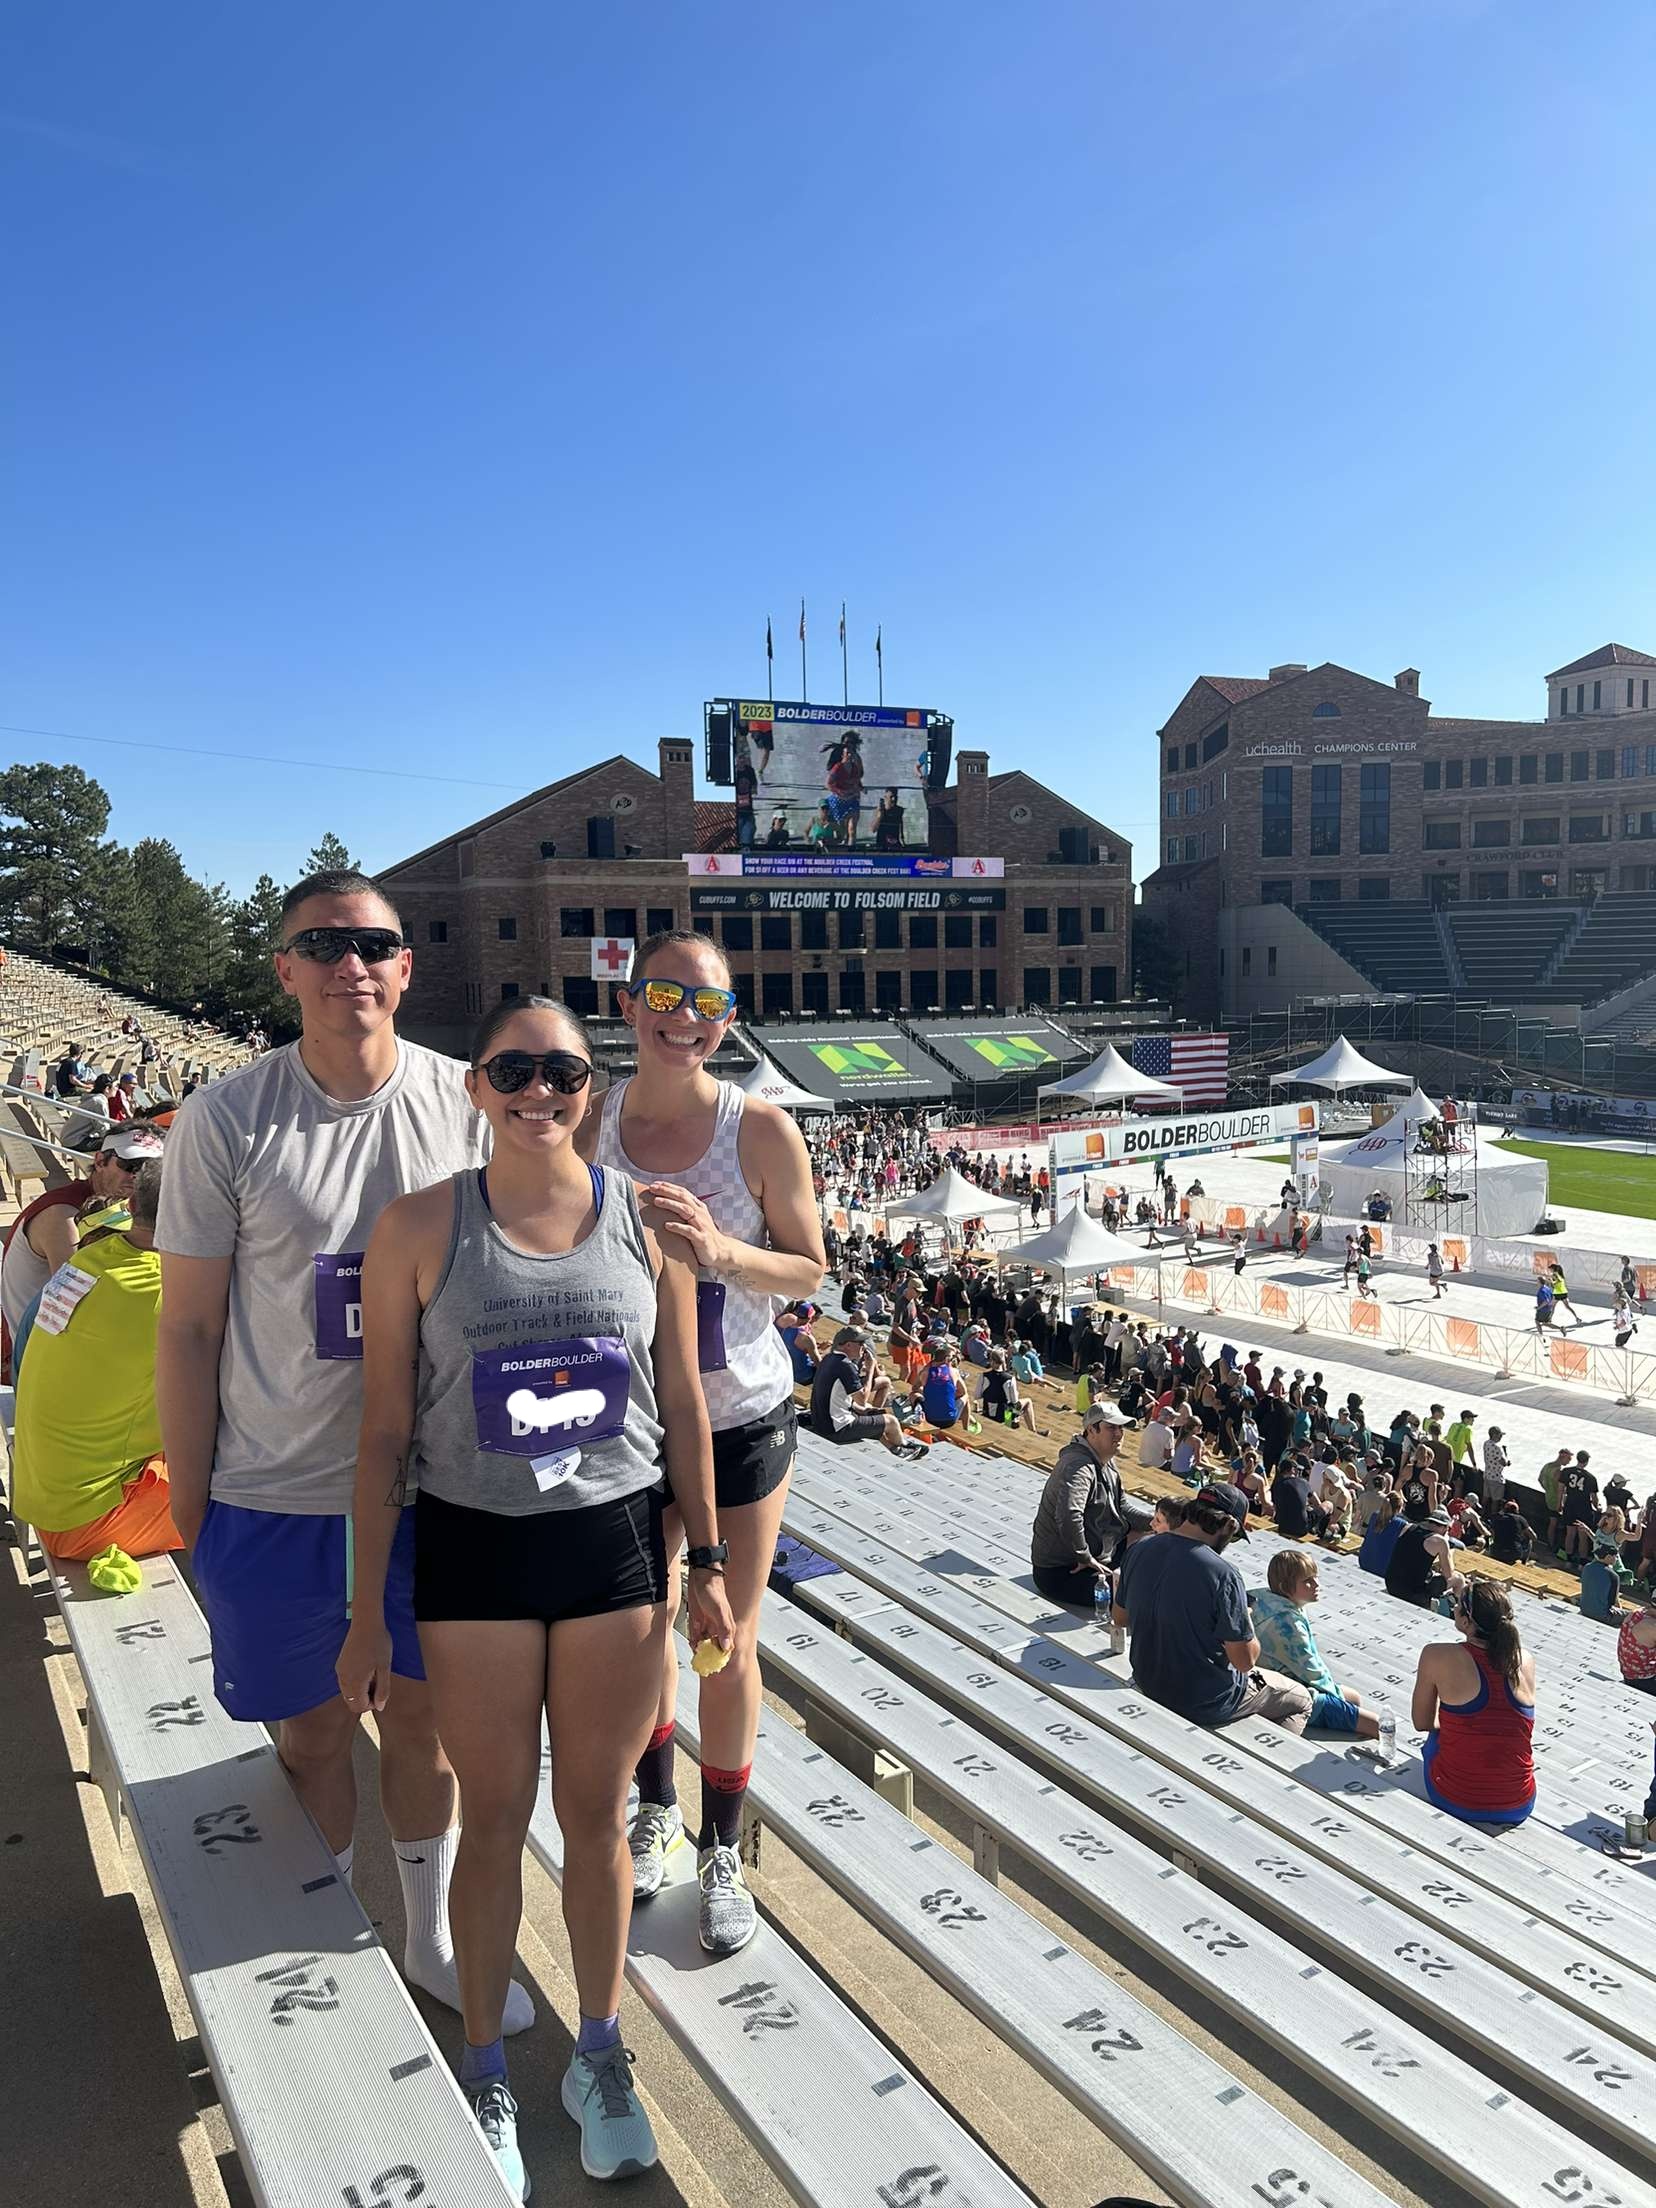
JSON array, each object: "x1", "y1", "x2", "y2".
[{"x1": 155, "y1": 1042, "x2": 486, "y2": 1517}]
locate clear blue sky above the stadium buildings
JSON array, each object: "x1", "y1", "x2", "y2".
[{"x1": 0, "y1": 0, "x2": 1656, "y2": 890}]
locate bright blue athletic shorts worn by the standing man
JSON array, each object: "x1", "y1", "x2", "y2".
[{"x1": 192, "y1": 1501, "x2": 426, "y2": 1724}]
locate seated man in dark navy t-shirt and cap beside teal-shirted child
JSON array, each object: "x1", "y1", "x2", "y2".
[{"x1": 1113, "y1": 1488, "x2": 1312, "y2": 1733}]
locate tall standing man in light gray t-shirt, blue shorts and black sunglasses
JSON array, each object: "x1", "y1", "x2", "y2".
[{"x1": 157, "y1": 872, "x2": 534, "y2": 2031}]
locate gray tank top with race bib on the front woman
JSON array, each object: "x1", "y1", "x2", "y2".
[{"x1": 411, "y1": 1168, "x2": 665, "y2": 1517}]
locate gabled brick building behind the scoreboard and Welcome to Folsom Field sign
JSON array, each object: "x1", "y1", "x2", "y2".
[{"x1": 382, "y1": 737, "x2": 1133, "y2": 1049}]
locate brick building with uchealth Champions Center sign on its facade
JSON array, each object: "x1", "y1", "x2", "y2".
[{"x1": 1144, "y1": 645, "x2": 1656, "y2": 1027}]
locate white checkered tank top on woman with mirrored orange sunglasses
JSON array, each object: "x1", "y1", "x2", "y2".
[{"x1": 596, "y1": 1080, "x2": 793, "y2": 1433}]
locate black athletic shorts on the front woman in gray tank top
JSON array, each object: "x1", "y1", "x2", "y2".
[{"x1": 415, "y1": 1488, "x2": 667, "y2": 1625}]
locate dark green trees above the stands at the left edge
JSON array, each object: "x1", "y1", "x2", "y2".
[{"x1": 0, "y1": 764, "x2": 355, "y2": 1033}]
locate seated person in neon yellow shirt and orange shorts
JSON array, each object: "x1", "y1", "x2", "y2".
[{"x1": 13, "y1": 1159, "x2": 183, "y2": 1561}]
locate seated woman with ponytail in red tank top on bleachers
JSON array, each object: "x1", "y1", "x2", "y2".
[{"x1": 1411, "y1": 1579, "x2": 1535, "y2": 1824}]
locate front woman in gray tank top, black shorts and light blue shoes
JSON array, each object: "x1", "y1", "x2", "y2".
[{"x1": 338, "y1": 998, "x2": 733, "y2": 2199}]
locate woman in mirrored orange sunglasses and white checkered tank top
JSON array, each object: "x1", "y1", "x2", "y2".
[{"x1": 583, "y1": 930, "x2": 826, "y2": 1954}]
